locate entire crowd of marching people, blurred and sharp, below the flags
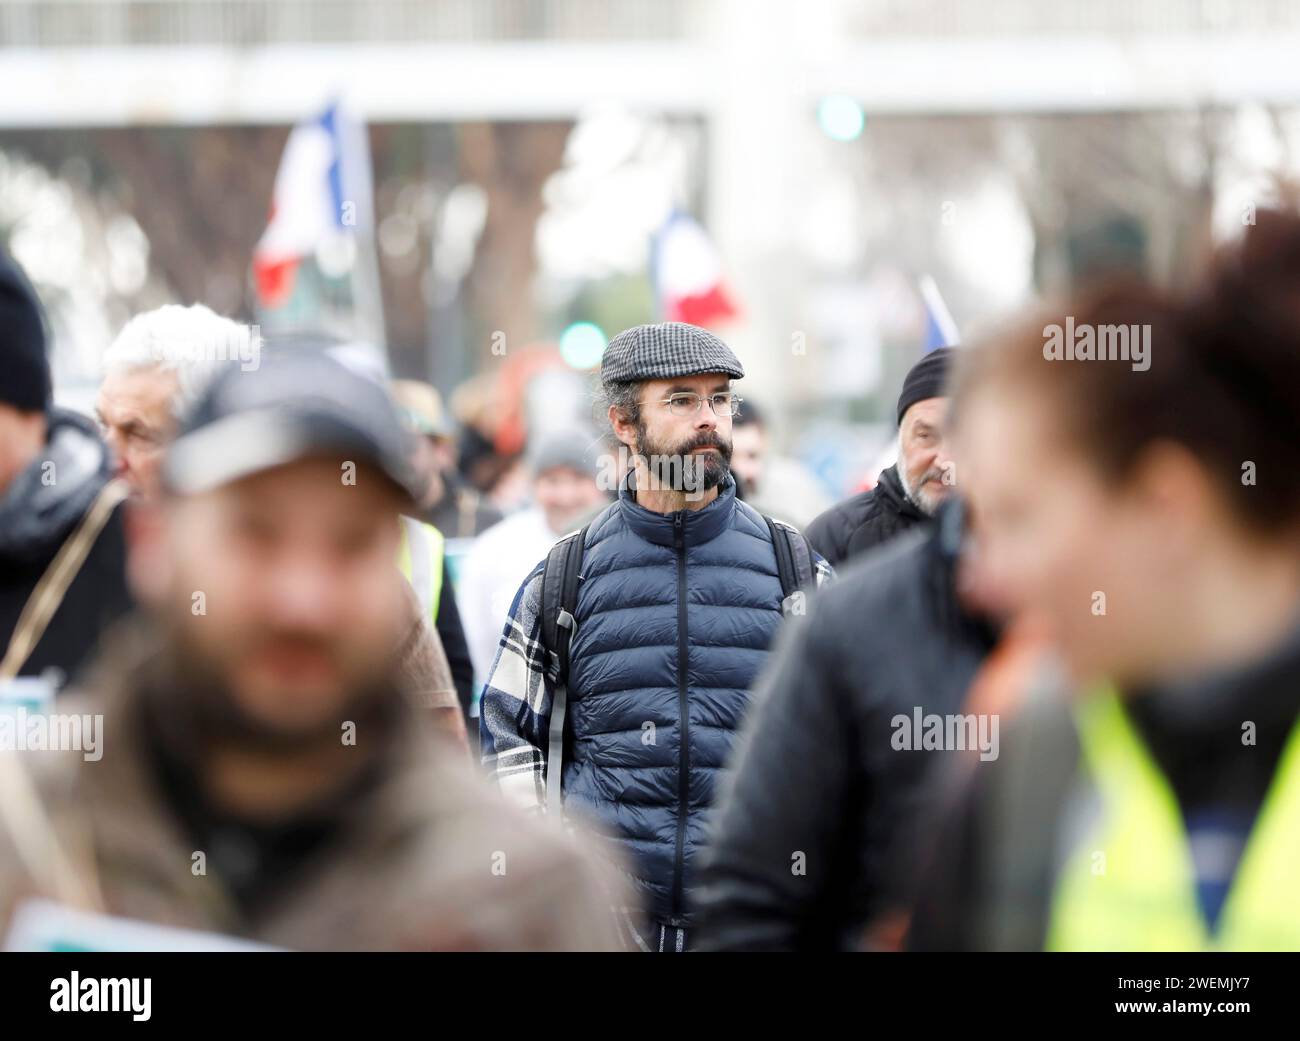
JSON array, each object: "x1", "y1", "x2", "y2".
[{"x1": 0, "y1": 212, "x2": 1300, "y2": 951}]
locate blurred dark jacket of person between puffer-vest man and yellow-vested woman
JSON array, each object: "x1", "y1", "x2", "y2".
[{"x1": 699, "y1": 500, "x2": 993, "y2": 950}]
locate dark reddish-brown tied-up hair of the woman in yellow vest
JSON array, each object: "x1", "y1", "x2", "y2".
[{"x1": 953, "y1": 211, "x2": 1300, "y2": 535}]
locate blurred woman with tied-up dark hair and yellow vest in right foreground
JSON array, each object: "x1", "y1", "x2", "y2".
[{"x1": 910, "y1": 211, "x2": 1300, "y2": 951}]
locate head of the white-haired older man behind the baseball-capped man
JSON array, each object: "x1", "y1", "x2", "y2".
[{"x1": 95, "y1": 304, "x2": 261, "y2": 496}]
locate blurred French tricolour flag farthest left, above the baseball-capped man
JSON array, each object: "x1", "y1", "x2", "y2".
[{"x1": 252, "y1": 103, "x2": 371, "y2": 308}]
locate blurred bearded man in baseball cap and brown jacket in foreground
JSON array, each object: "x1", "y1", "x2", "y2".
[{"x1": 0, "y1": 356, "x2": 621, "y2": 950}]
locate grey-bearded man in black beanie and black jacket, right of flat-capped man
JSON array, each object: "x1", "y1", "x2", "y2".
[{"x1": 805, "y1": 347, "x2": 956, "y2": 568}]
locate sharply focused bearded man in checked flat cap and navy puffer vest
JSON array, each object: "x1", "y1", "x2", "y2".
[{"x1": 480, "y1": 322, "x2": 829, "y2": 950}]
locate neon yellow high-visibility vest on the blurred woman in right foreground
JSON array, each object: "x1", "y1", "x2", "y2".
[{"x1": 1047, "y1": 689, "x2": 1300, "y2": 951}]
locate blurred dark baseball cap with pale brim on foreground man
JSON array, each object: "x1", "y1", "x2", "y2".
[{"x1": 163, "y1": 348, "x2": 417, "y2": 499}]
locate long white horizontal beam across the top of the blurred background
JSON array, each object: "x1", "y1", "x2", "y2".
[{"x1": 0, "y1": 32, "x2": 1300, "y2": 127}]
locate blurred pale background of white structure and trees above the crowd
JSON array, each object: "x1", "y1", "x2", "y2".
[{"x1": 0, "y1": 0, "x2": 1300, "y2": 491}]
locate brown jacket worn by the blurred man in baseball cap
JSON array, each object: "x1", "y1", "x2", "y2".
[{"x1": 0, "y1": 629, "x2": 623, "y2": 950}]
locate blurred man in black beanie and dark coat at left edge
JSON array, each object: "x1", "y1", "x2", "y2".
[{"x1": 0, "y1": 253, "x2": 130, "y2": 702}]
